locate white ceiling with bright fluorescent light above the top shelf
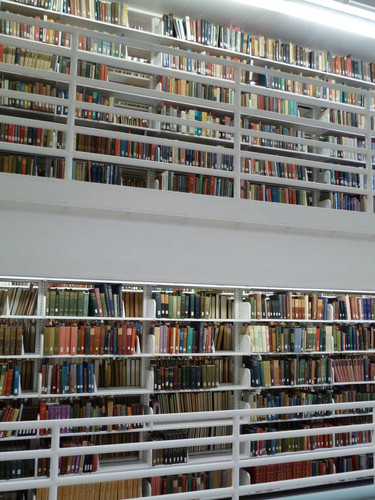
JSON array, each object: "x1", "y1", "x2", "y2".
[{"x1": 127, "y1": 0, "x2": 375, "y2": 61}]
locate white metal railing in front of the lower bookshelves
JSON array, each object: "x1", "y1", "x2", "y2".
[{"x1": 0, "y1": 402, "x2": 375, "y2": 500}]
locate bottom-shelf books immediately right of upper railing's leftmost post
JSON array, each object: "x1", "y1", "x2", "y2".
[{"x1": 72, "y1": 160, "x2": 147, "y2": 188}]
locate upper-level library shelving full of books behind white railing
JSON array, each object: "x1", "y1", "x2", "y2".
[{"x1": 0, "y1": 0, "x2": 375, "y2": 212}]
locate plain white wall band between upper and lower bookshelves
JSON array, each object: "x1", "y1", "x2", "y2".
[{"x1": 0, "y1": 174, "x2": 375, "y2": 290}]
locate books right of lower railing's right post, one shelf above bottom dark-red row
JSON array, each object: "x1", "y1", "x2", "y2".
[{"x1": 242, "y1": 417, "x2": 371, "y2": 457}]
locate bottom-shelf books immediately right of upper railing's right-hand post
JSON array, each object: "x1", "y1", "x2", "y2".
[{"x1": 240, "y1": 179, "x2": 312, "y2": 207}]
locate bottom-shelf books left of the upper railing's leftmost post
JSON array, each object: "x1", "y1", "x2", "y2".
[{"x1": 0, "y1": 155, "x2": 65, "y2": 180}]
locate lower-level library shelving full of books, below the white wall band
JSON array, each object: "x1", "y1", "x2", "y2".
[{"x1": 0, "y1": 277, "x2": 375, "y2": 498}]
